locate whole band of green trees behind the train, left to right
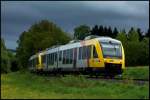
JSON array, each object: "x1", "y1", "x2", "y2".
[{"x1": 1, "y1": 20, "x2": 149, "y2": 72}]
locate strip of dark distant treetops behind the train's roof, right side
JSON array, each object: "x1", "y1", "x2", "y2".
[{"x1": 74, "y1": 25, "x2": 150, "y2": 41}]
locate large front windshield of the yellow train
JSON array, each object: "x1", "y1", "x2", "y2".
[{"x1": 101, "y1": 42, "x2": 122, "y2": 58}]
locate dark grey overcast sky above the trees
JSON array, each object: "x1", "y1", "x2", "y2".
[{"x1": 1, "y1": 1, "x2": 149, "y2": 49}]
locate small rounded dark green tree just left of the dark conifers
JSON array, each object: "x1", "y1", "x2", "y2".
[{"x1": 74, "y1": 25, "x2": 90, "y2": 40}]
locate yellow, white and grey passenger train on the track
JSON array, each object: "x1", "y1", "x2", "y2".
[{"x1": 29, "y1": 36, "x2": 125, "y2": 77}]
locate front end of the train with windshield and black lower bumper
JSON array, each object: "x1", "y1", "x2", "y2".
[{"x1": 100, "y1": 38, "x2": 125, "y2": 76}]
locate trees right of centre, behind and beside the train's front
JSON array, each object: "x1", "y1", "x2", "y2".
[{"x1": 74, "y1": 25, "x2": 150, "y2": 66}]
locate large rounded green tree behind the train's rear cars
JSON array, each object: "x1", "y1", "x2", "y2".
[{"x1": 16, "y1": 20, "x2": 70, "y2": 68}]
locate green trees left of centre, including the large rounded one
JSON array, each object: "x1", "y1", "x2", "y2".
[{"x1": 1, "y1": 20, "x2": 71, "y2": 73}]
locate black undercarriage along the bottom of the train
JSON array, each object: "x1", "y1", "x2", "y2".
[{"x1": 31, "y1": 63, "x2": 123, "y2": 78}]
